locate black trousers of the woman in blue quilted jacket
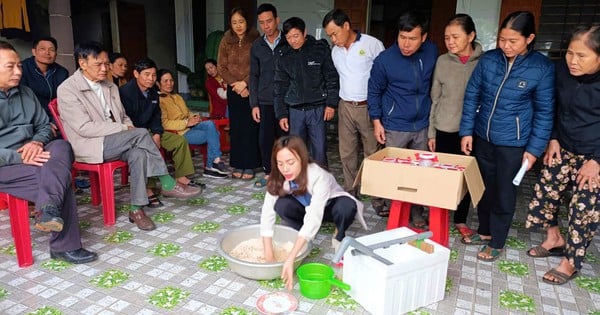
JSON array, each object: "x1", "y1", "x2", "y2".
[{"x1": 474, "y1": 137, "x2": 525, "y2": 249}]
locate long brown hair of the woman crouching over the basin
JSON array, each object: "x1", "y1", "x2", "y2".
[{"x1": 267, "y1": 136, "x2": 311, "y2": 196}]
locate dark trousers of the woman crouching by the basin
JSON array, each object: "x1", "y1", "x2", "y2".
[{"x1": 275, "y1": 195, "x2": 357, "y2": 242}]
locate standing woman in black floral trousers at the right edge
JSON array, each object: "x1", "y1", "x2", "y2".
[{"x1": 525, "y1": 24, "x2": 600, "y2": 284}]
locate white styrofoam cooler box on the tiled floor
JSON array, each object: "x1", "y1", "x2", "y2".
[{"x1": 343, "y1": 227, "x2": 450, "y2": 315}]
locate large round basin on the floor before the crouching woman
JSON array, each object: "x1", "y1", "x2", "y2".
[{"x1": 217, "y1": 224, "x2": 312, "y2": 280}]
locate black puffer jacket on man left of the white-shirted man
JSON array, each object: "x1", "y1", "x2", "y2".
[{"x1": 274, "y1": 35, "x2": 339, "y2": 119}]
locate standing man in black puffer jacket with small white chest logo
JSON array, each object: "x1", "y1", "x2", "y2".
[{"x1": 274, "y1": 17, "x2": 339, "y2": 166}]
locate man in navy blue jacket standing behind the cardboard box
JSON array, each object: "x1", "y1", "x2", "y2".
[{"x1": 367, "y1": 11, "x2": 438, "y2": 228}]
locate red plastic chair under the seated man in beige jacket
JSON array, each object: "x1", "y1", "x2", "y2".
[{"x1": 48, "y1": 99, "x2": 129, "y2": 226}]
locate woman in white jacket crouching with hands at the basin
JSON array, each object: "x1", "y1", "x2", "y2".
[{"x1": 260, "y1": 136, "x2": 367, "y2": 290}]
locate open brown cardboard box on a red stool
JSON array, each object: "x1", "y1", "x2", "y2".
[{"x1": 354, "y1": 148, "x2": 485, "y2": 210}]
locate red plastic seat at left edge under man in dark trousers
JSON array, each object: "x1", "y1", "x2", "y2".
[{"x1": 0, "y1": 192, "x2": 33, "y2": 267}]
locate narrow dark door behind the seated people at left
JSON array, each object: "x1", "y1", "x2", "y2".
[{"x1": 117, "y1": 1, "x2": 148, "y2": 80}]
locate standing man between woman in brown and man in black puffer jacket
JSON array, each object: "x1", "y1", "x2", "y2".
[{"x1": 249, "y1": 3, "x2": 287, "y2": 187}]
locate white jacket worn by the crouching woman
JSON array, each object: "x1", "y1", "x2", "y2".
[{"x1": 260, "y1": 163, "x2": 367, "y2": 241}]
